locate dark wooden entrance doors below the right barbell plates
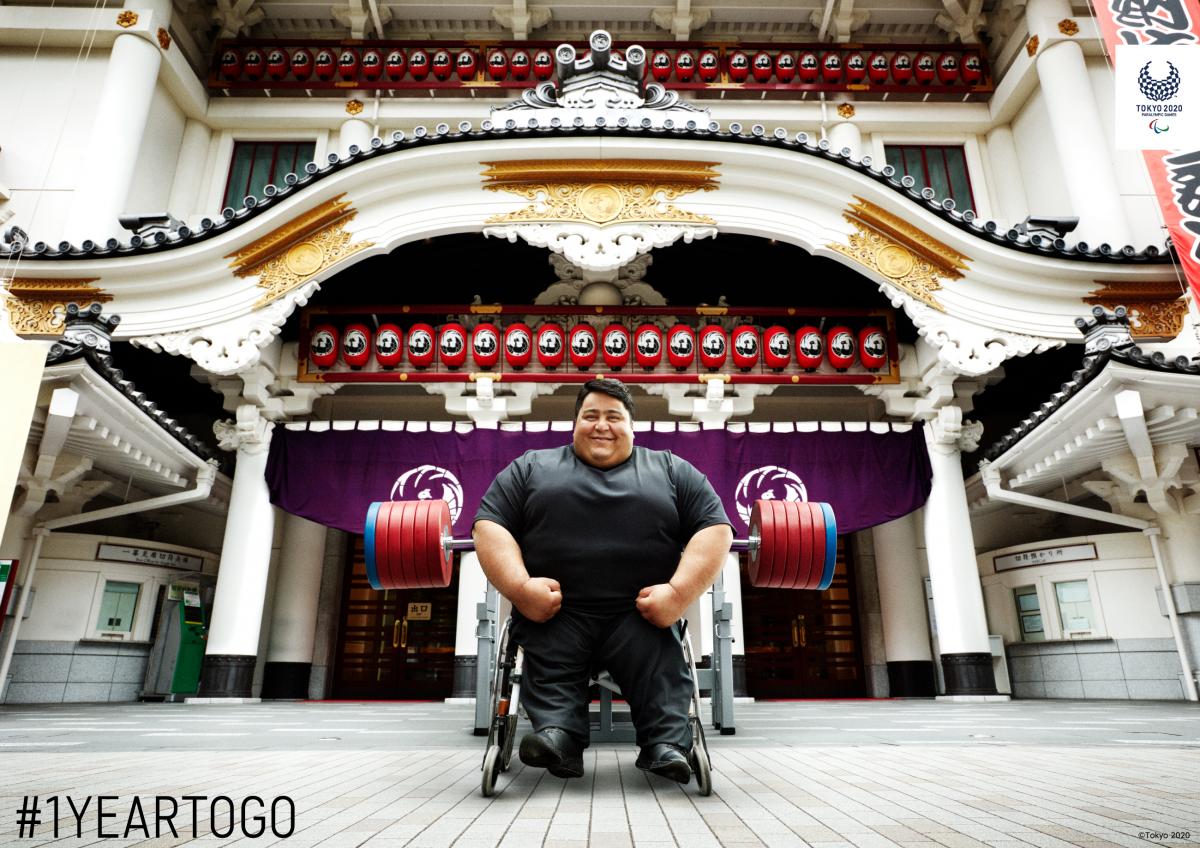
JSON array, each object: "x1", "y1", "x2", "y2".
[{"x1": 742, "y1": 539, "x2": 866, "y2": 698}]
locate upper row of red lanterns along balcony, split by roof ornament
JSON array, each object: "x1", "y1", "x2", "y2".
[{"x1": 221, "y1": 47, "x2": 983, "y2": 85}]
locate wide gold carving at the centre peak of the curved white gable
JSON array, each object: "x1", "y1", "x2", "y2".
[{"x1": 482, "y1": 160, "x2": 720, "y2": 225}]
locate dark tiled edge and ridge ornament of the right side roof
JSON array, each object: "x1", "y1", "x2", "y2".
[{"x1": 983, "y1": 306, "x2": 1200, "y2": 462}]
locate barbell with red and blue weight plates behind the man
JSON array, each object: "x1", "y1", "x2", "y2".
[{"x1": 364, "y1": 500, "x2": 838, "y2": 591}]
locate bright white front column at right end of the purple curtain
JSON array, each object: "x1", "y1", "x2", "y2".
[{"x1": 925, "y1": 407, "x2": 996, "y2": 696}]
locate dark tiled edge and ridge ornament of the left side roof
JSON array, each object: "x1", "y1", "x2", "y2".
[{"x1": 46, "y1": 303, "x2": 216, "y2": 459}]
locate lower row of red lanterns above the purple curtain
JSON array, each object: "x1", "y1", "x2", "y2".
[{"x1": 308, "y1": 321, "x2": 888, "y2": 372}]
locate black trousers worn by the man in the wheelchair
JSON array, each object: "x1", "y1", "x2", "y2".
[{"x1": 512, "y1": 608, "x2": 692, "y2": 751}]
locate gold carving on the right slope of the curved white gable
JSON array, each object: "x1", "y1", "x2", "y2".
[{"x1": 829, "y1": 197, "x2": 971, "y2": 312}]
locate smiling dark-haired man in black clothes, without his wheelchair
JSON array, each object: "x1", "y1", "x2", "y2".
[{"x1": 473, "y1": 380, "x2": 733, "y2": 783}]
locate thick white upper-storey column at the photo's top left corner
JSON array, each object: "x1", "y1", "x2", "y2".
[{"x1": 66, "y1": 0, "x2": 170, "y2": 238}]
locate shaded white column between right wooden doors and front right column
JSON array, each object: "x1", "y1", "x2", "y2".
[{"x1": 872, "y1": 513, "x2": 934, "y2": 696}]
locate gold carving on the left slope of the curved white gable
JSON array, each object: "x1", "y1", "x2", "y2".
[{"x1": 226, "y1": 194, "x2": 373, "y2": 308}]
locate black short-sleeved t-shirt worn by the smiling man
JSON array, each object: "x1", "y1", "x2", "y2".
[{"x1": 475, "y1": 445, "x2": 730, "y2": 614}]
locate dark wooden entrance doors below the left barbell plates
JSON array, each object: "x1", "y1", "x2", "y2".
[{"x1": 332, "y1": 536, "x2": 458, "y2": 700}]
